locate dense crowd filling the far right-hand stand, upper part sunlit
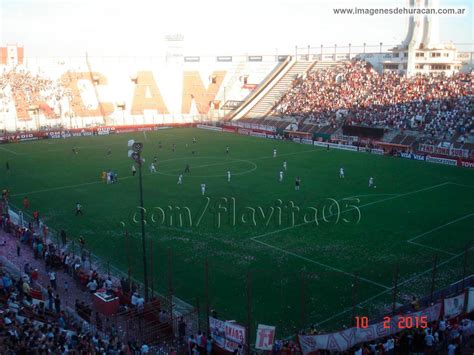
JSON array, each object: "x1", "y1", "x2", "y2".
[{"x1": 275, "y1": 61, "x2": 474, "y2": 140}]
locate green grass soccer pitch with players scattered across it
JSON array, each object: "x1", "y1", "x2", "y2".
[{"x1": 0, "y1": 128, "x2": 474, "y2": 337}]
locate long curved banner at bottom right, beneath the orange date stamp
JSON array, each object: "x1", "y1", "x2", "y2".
[{"x1": 298, "y1": 303, "x2": 441, "y2": 355}]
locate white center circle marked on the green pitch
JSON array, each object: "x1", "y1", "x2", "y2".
[{"x1": 156, "y1": 156, "x2": 257, "y2": 178}]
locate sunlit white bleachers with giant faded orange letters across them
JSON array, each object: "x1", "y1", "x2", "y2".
[{"x1": 0, "y1": 56, "x2": 280, "y2": 131}]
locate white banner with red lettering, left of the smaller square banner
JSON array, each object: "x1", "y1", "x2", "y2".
[{"x1": 209, "y1": 317, "x2": 246, "y2": 352}]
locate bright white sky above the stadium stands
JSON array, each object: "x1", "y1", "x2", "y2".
[{"x1": 0, "y1": 0, "x2": 474, "y2": 57}]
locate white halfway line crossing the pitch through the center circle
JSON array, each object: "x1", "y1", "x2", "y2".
[{"x1": 10, "y1": 147, "x2": 323, "y2": 197}]
